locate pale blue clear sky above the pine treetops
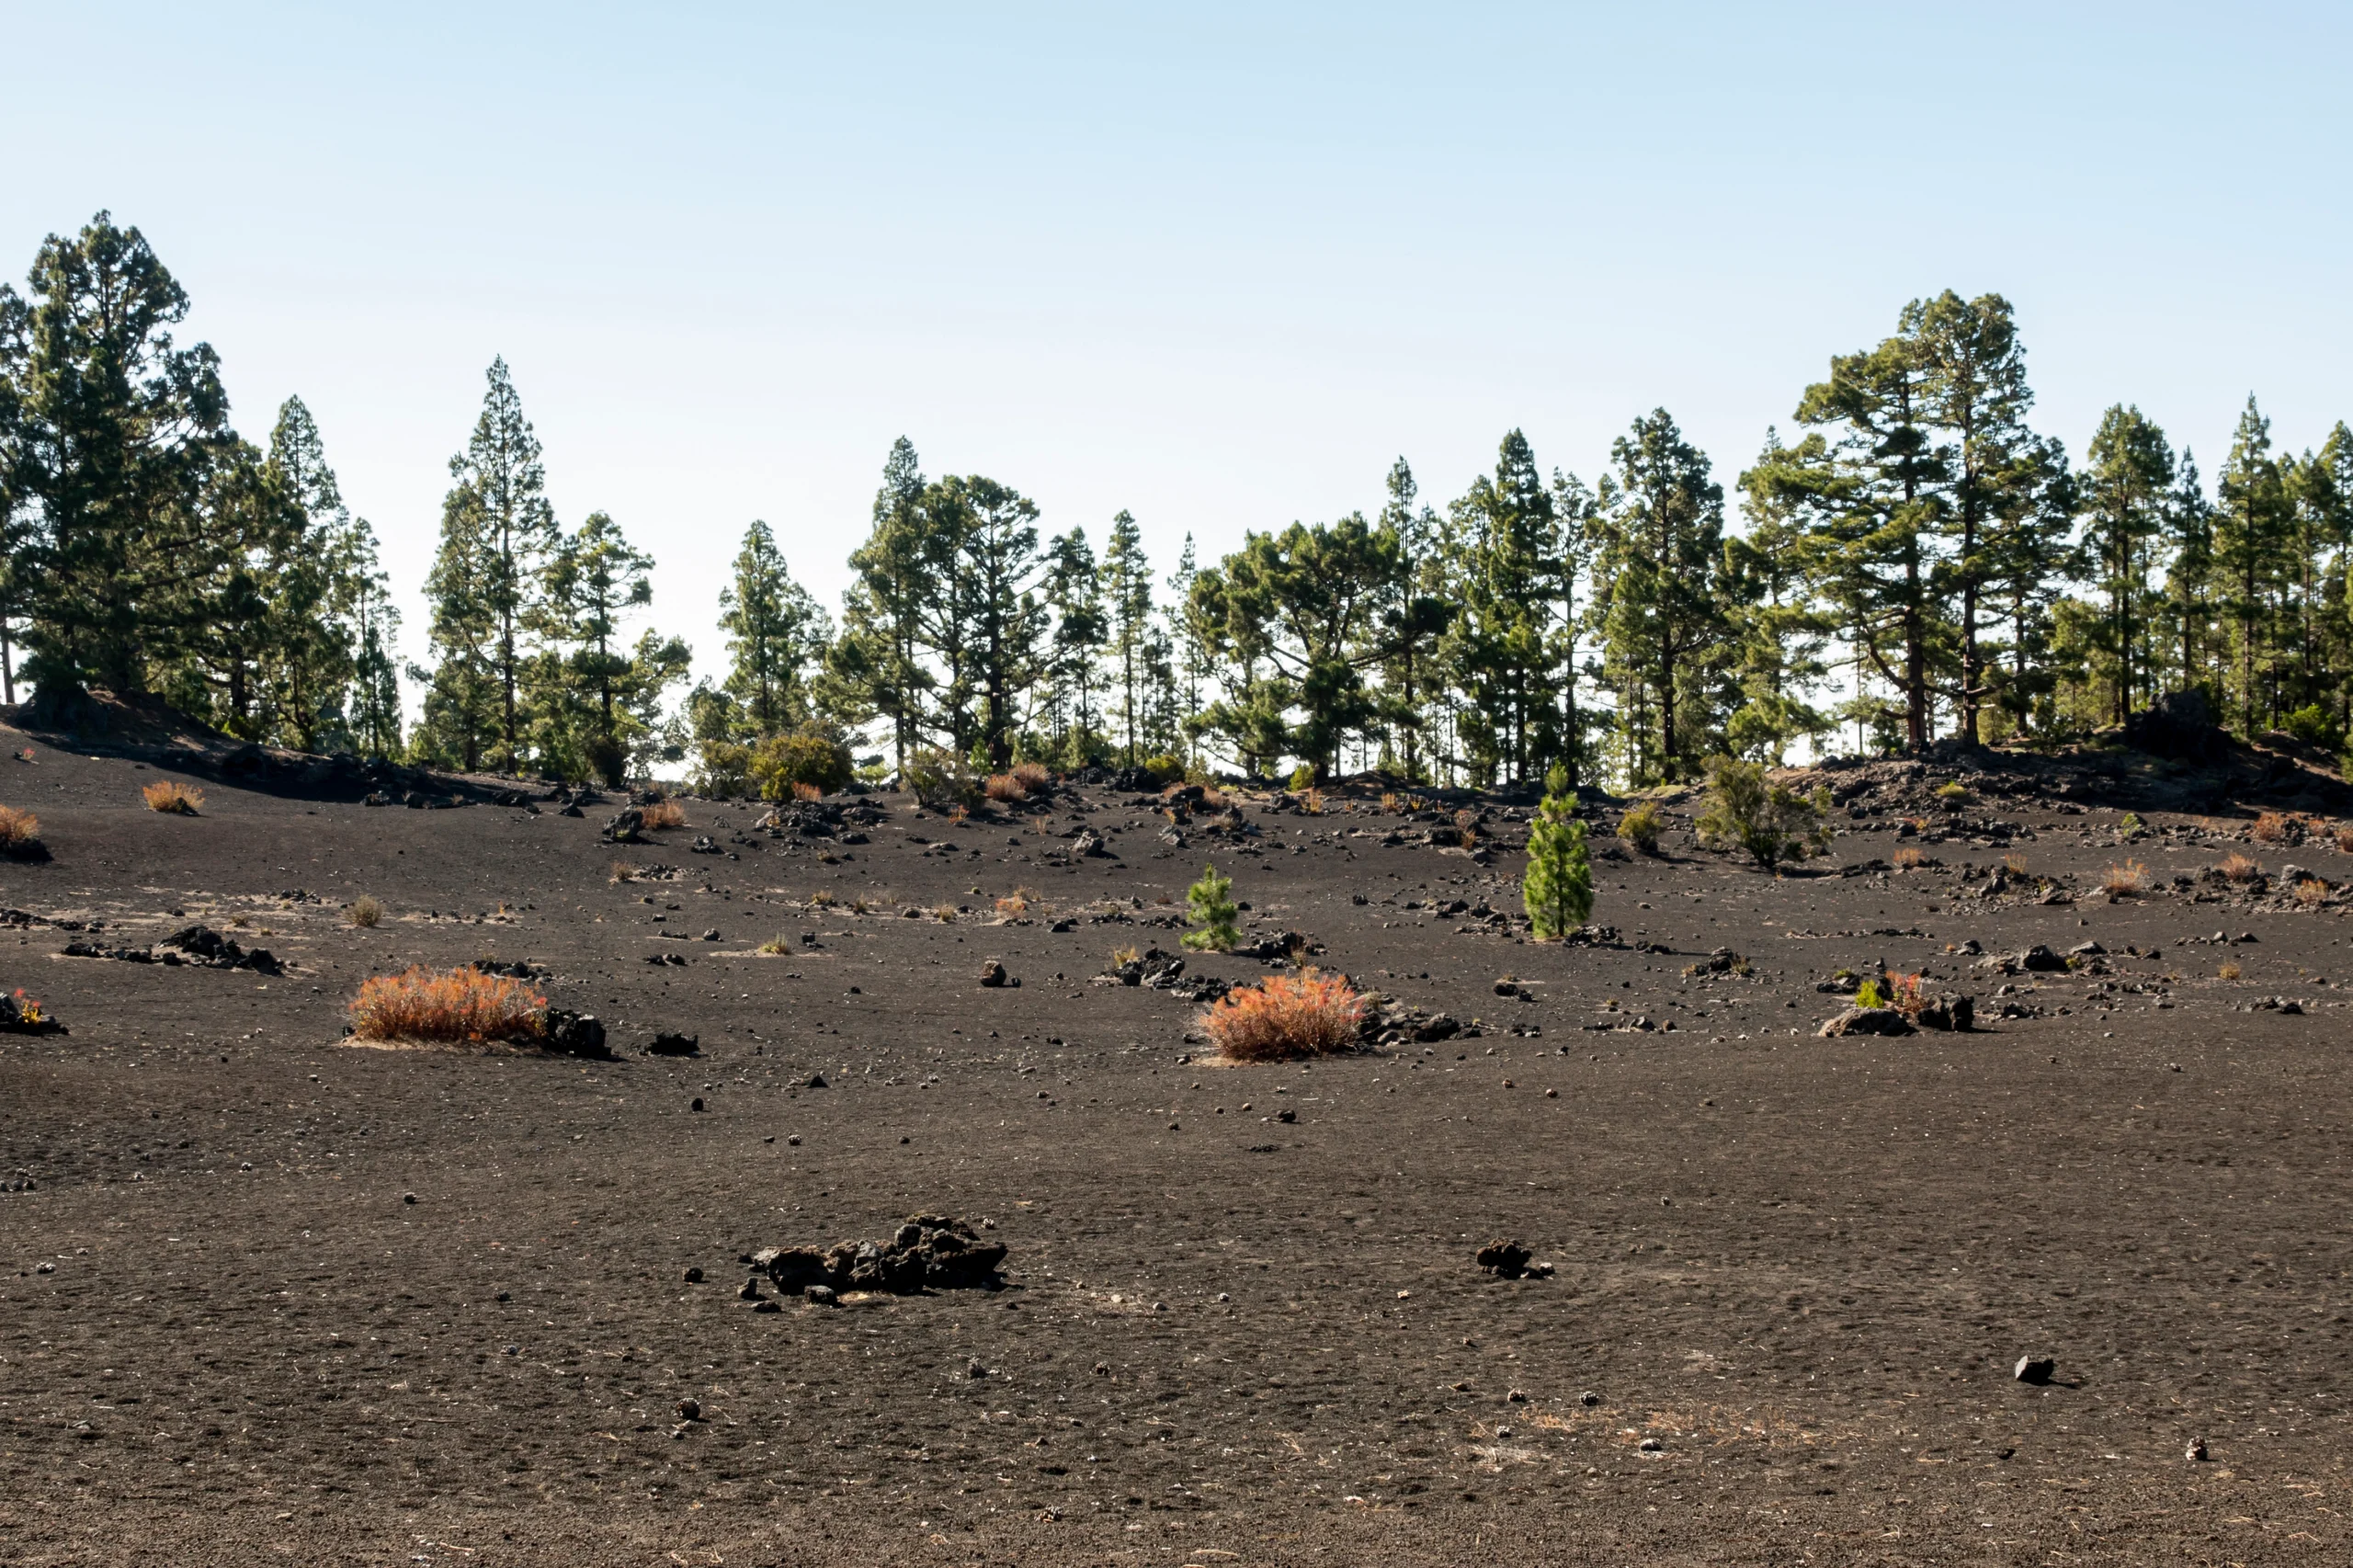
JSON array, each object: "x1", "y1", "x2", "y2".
[{"x1": 0, "y1": 0, "x2": 2353, "y2": 706}]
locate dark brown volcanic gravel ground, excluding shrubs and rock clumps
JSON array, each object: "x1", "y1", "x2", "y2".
[{"x1": 0, "y1": 733, "x2": 2353, "y2": 1568}]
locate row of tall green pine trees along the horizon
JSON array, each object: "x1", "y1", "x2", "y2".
[{"x1": 0, "y1": 214, "x2": 2353, "y2": 789}]
